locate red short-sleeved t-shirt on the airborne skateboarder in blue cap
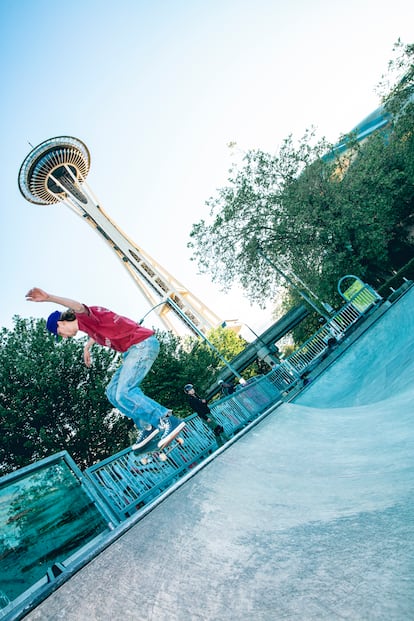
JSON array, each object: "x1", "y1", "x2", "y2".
[{"x1": 76, "y1": 304, "x2": 154, "y2": 352}]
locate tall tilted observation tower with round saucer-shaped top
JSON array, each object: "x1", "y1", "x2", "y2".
[{"x1": 18, "y1": 136, "x2": 221, "y2": 336}]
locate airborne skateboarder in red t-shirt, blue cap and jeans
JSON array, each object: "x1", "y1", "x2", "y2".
[{"x1": 26, "y1": 287, "x2": 185, "y2": 450}]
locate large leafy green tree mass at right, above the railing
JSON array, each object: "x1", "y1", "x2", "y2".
[{"x1": 189, "y1": 46, "x2": 414, "y2": 324}]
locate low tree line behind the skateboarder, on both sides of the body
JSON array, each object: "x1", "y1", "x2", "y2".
[{"x1": 0, "y1": 317, "x2": 256, "y2": 473}]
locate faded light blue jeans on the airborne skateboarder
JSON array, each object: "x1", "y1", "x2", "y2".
[{"x1": 106, "y1": 336, "x2": 169, "y2": 428}]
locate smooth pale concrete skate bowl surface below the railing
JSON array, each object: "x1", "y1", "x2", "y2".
[{"x1": 1, "y1": 288, "x2": 414, "y2": 621}]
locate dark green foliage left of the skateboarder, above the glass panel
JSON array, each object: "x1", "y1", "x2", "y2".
[{"x1": 0, "y1": 317, "x2": 129, "y2": 472}]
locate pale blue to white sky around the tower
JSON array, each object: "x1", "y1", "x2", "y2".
[{"x1": 0, "y1": 0, "x2": 414, "y2": 330}]
